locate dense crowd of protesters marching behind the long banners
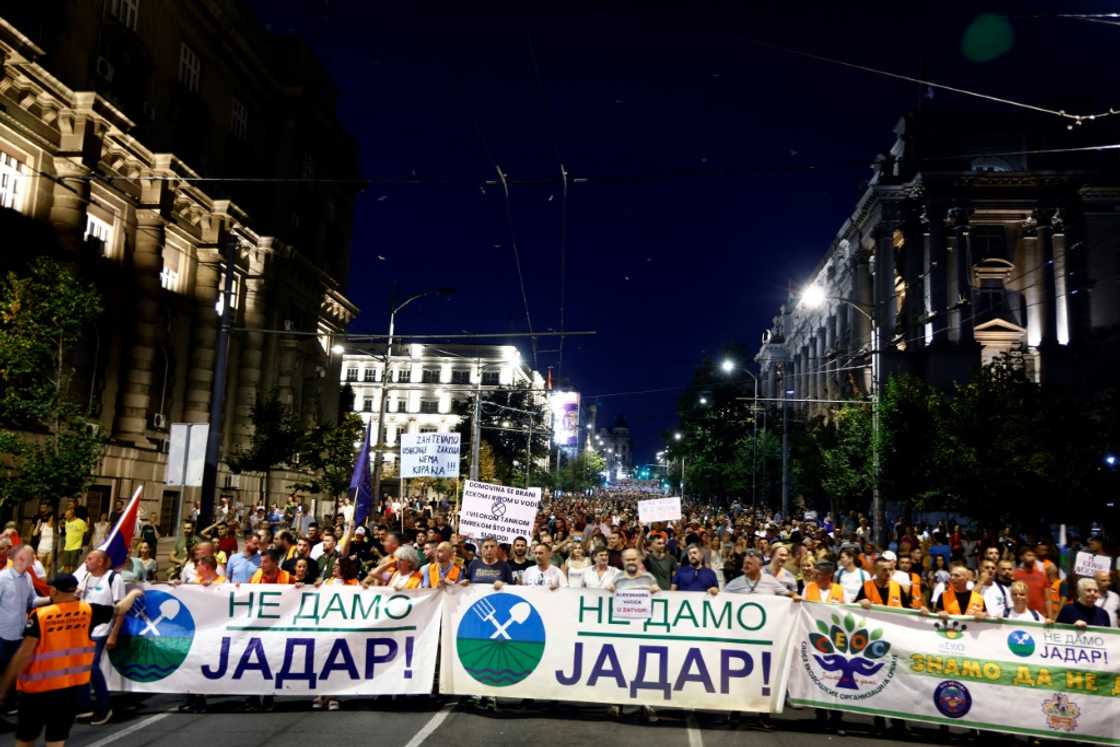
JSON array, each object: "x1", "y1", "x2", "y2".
[{"x1": 0, "y1": 495, "x2": 1120, "y2": 732}]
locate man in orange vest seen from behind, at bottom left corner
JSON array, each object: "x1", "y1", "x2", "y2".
[{"x1": 0, "y1": 573, "x2": 143, "y2": 747}]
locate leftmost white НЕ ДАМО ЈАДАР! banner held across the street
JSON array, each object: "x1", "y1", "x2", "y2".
[{"x1": 105, "y1": 585, "x2": 444, "y2": 697}]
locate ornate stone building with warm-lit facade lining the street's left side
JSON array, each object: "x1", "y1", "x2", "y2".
[{"x1": 0, "y1": 0, "x2": 357, "y2": 531}]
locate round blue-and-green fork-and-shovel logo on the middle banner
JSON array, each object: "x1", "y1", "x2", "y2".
[{"x1": 455, "y1": 594, "x2": 544, "y2": 688}]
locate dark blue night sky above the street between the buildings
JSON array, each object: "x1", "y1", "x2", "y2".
[{"x1": 253, "y1": 0, "x2": 1120, "y2": 461}]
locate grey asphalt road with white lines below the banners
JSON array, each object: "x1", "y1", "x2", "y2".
[{"x1": 21, "y1": 695, "x2": 1012, "y2": 747}]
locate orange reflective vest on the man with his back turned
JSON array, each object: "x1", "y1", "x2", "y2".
[{"x1": 16, "y1": 600, "x2": 95, "y2": 692}]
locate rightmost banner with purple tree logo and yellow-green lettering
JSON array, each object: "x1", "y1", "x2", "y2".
[{"x1": 790, "y1": 603, "x2": 1120, "y2": 745}]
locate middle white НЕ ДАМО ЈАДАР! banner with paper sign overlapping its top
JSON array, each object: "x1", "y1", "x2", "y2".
[{"x1": 440, "y1": 586, "x2": 794, "y2": 712}]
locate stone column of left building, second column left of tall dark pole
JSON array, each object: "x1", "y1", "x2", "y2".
[{"x1": 113, "y1": 207, "x2": 164, "y2": 448}]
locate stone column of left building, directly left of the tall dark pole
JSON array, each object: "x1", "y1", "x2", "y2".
[{"x1": 184, "y1": 248, "x2": 221, "y2": 422}]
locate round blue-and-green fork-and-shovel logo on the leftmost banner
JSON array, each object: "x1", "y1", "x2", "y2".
[{"x1": 109, "y1": 589, "x2": 195, "y2": 682}]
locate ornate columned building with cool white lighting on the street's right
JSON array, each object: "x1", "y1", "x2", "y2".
[{"x1": 756, "y1": 113, "x2": 1120, "y2": 414}]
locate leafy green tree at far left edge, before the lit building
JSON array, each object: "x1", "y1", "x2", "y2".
[{"x1": 0, "y1": 256, "x2": 104, "y2": 515}]
